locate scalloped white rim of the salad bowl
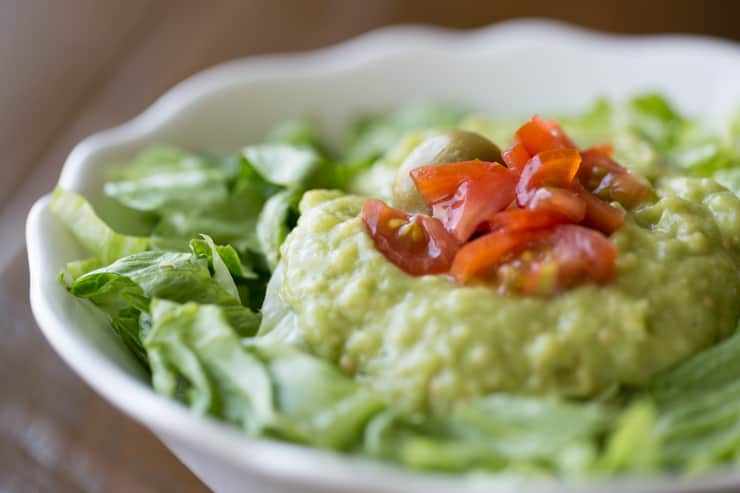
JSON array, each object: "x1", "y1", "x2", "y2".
[{"x1": 26, "y1": 20, "x2": 740, "y2": 493}]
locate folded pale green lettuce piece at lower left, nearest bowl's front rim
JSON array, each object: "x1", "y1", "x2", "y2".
[{"x1": 144, "y1": 299, "x2": 277, "y2": 426}]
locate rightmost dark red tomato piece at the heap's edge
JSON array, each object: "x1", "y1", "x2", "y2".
[{"x1": 578, "y1": 146, "x2": 652, "y2": 208}]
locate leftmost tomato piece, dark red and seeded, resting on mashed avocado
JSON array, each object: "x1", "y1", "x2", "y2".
[{"x1": 362, "y1": 199, "x2": 459, "y2": 276}]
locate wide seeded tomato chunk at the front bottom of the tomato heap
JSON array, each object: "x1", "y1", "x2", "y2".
[{"x1": 450, "y1": 224, "x2": 617, "y2": 295}]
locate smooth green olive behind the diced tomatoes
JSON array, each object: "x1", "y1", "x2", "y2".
[{"x1": 393, "y1": 130, "x2": 501, "y2": 214}]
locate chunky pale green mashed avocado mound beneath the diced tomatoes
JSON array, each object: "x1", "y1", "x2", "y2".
[{"x1": 262, "y1": 178, "x2": 740, "y2": 413}]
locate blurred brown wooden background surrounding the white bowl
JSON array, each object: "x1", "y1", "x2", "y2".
[{"x1": 0, "y1": 0, "x2": 740, "y2": 492}]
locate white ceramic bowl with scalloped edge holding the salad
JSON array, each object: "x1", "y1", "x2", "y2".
[{"x1": 27, "y1": 21, "x2": 740, "y2": 493}]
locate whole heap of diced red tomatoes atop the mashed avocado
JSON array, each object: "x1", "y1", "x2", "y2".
[{"x1": 362, "y1": 116, "x2": 632, "y2": 295}]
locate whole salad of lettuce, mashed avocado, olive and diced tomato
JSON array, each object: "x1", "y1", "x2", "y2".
[{"x1": 50, "y1": 94, "x2": 740, "y2": 477}]
